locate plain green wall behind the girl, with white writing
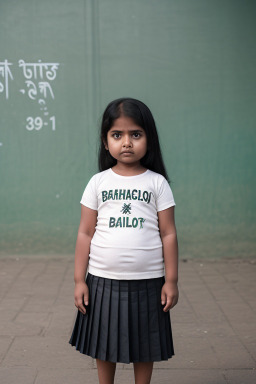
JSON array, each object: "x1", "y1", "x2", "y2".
[{"x1": 0, "y1": 0, "x2": 256, "y2": 258}]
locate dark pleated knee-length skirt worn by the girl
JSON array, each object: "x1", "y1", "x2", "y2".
[{"x1": 69, "y1": 273, "x2": 174, "y2": 363}]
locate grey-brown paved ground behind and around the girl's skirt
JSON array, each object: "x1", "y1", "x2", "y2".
[{"x1": 0, "y1": 255, "x2": 256, "y2": 384}]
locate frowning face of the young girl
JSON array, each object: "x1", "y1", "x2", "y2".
[{"x1": 104, "y1": 116, "x2": 147, "y2": 166}]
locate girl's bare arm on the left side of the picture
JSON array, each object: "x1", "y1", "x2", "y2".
[{"x1": 74, "y1": 204, "x2": 98, "y2": 313}]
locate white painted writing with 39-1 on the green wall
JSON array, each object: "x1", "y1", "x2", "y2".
[{"x1": 0, "y1": 59, "x2": 60, "y2": 131}]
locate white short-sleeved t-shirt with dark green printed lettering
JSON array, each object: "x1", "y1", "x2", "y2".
[{"x1": 80, "y1": 168, "x2": 176, "y2": 280}]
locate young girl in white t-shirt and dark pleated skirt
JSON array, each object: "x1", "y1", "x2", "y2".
[{"x1": 69, "y1": 98, "x2": 178, "y2": 384}]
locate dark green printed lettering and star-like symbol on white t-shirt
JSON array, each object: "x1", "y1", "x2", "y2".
[{"x1": 101, "y1": 189, "x2": 153, "y2": 229}]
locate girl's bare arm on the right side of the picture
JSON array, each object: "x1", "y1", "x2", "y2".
[{"x1": 158, "y1": 206, "x2": 179, "y2": 312}]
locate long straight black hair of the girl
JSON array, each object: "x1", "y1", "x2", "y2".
[{"x1": 98, "y1": 97, "x2": 170, "y2": 182}]
